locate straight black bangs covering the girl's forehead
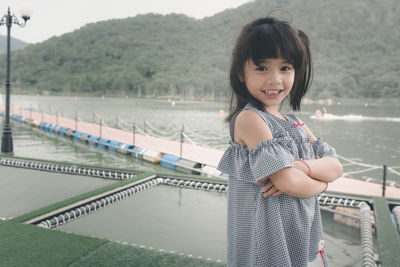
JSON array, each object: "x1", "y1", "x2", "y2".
[{"x1": 248, "y1": 24, "x2": 301, "y2": 67}]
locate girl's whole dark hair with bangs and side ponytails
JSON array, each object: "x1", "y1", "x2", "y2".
[{"x1": 227, "y1": 17, "x2": 312, "y2": 121}]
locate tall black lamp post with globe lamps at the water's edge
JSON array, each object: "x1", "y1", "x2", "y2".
[{"x1": 0, "y1": 8, "x2": 30, "y2": 155}]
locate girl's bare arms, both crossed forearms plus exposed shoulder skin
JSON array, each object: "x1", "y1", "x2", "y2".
[{"x1": 234, "y1": 110, "x2": 342, "y2": 200}]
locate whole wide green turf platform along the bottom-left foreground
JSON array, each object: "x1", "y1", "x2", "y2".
[{"x1": 0, "y1": 221, "x2": 225, "y2": 267}]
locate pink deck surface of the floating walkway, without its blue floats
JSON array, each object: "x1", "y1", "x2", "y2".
[{"x1": 2, "y1": 105, "x2": 400, "y2": 199}]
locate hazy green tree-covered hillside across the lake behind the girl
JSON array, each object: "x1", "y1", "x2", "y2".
[{"x1": 0, "y1": 0, "x2": 400, "y2": 98}]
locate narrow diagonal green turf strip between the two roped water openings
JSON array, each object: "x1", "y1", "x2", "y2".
[{"x1": 12, "y1": 172, "x2": 154, "y2": 222}]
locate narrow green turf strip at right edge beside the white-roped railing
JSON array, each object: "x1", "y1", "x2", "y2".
[{"x1": 373, "y1": 197, "x2": 400, "y2": 267}]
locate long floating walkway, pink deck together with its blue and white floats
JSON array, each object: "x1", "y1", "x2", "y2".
[{"x1": 3, "y1": 108, "x2": 400, "y2": 199}]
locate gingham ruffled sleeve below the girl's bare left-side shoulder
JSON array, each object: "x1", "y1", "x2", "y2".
[{"x1": 218, "y1": 138, "x2": 294, "y2": 183}]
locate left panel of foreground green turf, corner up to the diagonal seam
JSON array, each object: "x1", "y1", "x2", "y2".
[{"x1": 0, "y1": 221, "x2": 108, "y2": 267}]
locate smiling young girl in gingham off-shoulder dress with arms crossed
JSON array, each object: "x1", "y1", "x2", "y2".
[{"x1": 218, "y1": 17, "x2": 342, "y2": 267}]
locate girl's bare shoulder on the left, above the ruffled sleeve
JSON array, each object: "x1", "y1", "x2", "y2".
[{"x1": 234, "y1": 110, "x2": 272, "y2": 149}]
